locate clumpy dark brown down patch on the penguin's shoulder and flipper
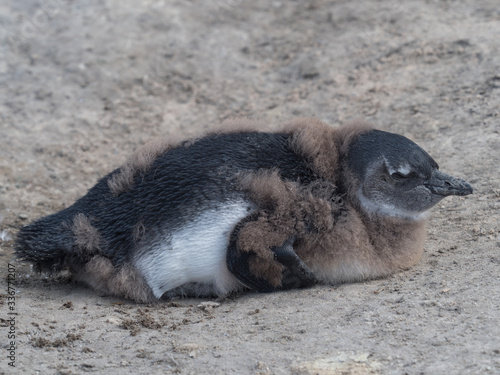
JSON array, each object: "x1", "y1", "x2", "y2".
[{"x1": 237, "y1": 171, "x2": 342, "y2": 287}]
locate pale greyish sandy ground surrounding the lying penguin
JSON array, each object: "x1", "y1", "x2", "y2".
[{"x1": 0, "y1": 0, "x2": 500, "y2": 374}]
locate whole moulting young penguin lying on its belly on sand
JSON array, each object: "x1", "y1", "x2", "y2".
[{"x1": 14, "y1": 118, "x2": 473, "y2": 302}]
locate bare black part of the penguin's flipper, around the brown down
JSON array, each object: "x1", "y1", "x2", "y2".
[{"x1": 226, "y1": 220, "x2": 317, "y2": 293}]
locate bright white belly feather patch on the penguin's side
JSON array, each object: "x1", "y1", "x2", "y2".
[{"x1": 135, "y1": 200, "x2": 253, "y2": 298}]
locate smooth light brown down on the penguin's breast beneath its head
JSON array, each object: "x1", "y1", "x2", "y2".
[{"x1": 295, "y1": 212, "x2": 425, "y2": 284}]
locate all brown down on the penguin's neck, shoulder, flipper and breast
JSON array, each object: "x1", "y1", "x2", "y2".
[{"x1": 237, "y1": 119, "x2": 425, "y2": 287}]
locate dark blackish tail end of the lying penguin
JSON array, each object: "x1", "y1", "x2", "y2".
[{"x1": 14, "y1": 214, "x2": 74, "y2": 274}]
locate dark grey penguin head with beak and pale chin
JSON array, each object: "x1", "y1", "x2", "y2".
[{"x1": 348, "y1": 130, "x2": 472, "y2": 220}]
